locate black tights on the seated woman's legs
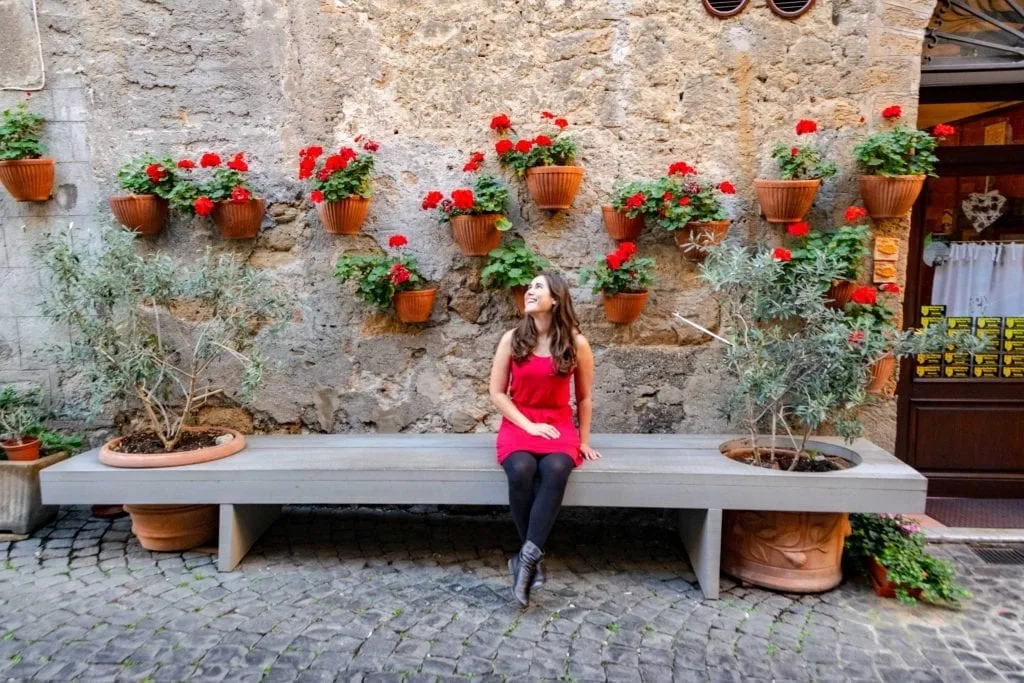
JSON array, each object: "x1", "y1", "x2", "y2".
[{"x1": 502, "y1": 451, "x2": 575, "y2": 548}]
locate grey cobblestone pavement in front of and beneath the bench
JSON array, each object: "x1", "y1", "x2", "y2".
[{"x1": 0, "y1": 508, "x2": 1024, "y2": 682}]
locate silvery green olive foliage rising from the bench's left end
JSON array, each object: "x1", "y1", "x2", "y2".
[{"x1": 40, "y1": 229, "x2": 291, "y2": 450}]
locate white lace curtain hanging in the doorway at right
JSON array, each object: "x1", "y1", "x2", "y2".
[{"x1": 932, "y1": 242, "x2": 1024, "y2": 317}]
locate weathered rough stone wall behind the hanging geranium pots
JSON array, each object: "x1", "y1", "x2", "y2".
[{"x1": 0, "y1": 0, "x2": 934, "y2": 447}]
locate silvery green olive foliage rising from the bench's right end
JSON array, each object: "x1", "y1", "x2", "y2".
[{"x1": 700, "y1": 245, "x2": 984, "y2": 450}]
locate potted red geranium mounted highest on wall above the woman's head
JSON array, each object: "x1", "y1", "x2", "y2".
[{"x1": 490, "y1": 112, "x2": 583, "y2": 211}]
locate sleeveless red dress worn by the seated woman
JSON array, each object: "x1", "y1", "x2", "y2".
[{"x1": 498, "y1": 353, "x2": 583, "y2": 467}]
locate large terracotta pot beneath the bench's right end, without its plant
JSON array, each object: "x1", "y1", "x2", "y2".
[{"x1": 722, "y1": 509, "x2": 850, "y2": 593}]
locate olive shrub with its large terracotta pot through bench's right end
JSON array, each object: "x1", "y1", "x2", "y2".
[{"x1": 692, "y1": 246, "x2": 984, "y2": 593}]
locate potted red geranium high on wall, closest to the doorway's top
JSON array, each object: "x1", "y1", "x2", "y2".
[{"x1": 853, "y1": 104, "x2": 956, "y2": 219}]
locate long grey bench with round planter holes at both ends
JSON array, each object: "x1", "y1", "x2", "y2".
[{"x1": 42, "y1": 434, "x2": 927, "y2": 598}]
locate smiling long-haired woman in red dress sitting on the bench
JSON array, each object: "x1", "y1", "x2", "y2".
[{"x1": 490, "y1": 272, "x2": 601, "y2": 606}]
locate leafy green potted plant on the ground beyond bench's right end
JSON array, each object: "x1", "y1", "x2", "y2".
[{"x1": 846, "y1": 513, "x2": 971, "y2": 608}]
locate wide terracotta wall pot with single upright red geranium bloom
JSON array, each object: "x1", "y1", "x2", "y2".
[{"x1": 754, "y1": 119, "x2": 838, "y2": 223}]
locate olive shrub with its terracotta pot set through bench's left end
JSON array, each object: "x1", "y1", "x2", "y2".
[{"x1": 40, "y1": 229, "x2": 292, "y2": 550}]
